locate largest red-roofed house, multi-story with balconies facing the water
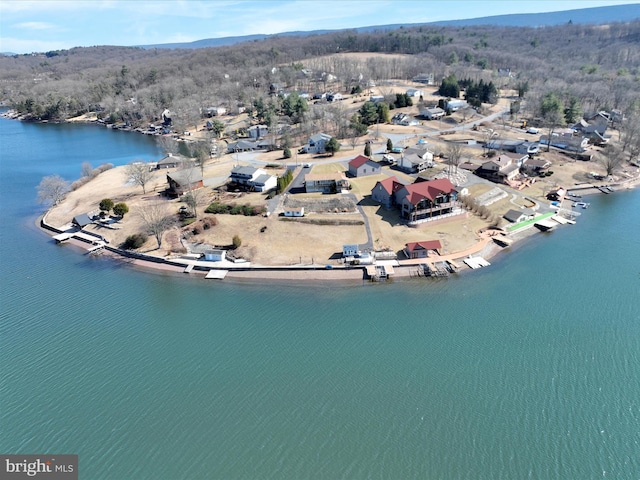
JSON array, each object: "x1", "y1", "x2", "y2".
[{"x1": 394, "y1": 178, "x2": 461, "y2": 223}]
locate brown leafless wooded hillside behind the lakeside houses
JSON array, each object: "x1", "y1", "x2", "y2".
[{"x1": 0, "y1": 21, "x2": 640, "y2": 126}]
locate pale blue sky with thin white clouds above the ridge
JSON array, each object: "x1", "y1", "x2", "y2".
[{"x1": 0, "y1": 0, "x2": 639, "y2": 53}]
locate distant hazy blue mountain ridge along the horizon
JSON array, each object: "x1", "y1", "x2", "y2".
[{"x1": 138, "y1": 3, "x2": 640, "y2": 49}]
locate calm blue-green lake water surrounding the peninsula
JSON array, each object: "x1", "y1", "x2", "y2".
[{"x1": 0, "y1": 114, "x2": 640, "y2": 480}]
